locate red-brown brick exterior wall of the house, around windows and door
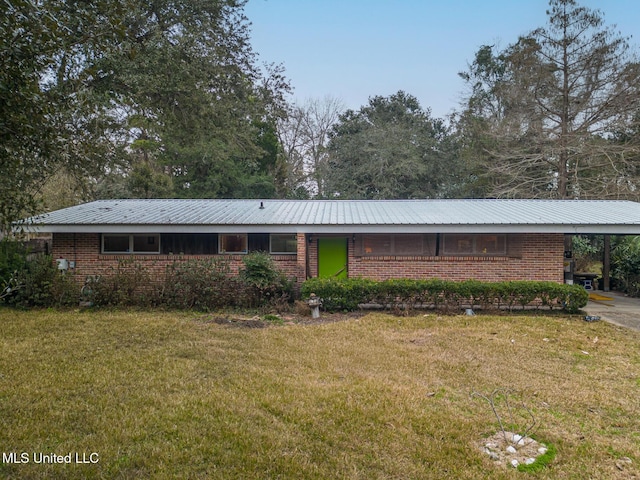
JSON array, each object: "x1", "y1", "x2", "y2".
[{"x1": 51, "y1": 233, "x2": 564, "y2": 285}]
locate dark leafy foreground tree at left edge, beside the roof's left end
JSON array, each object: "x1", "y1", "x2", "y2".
[{"x1": 0, "y1": 0, "x2": 118, "y2": 230}]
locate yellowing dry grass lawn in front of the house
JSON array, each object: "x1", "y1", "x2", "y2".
[{"x1": 0, "y1": 310, "x2": 640, "y2": 479}]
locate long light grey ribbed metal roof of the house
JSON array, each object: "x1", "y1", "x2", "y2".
[{"x1": 18, "y1": 199, "x2": 640, "y2": 234}]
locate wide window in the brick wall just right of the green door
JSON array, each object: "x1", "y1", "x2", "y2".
[{"x1": 359, "y1": 234, "x2": 436, "y2": 255}]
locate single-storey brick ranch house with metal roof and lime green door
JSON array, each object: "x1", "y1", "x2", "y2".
[{"x1": 23, "y1": 199, "x2": 640, "y2": 286}]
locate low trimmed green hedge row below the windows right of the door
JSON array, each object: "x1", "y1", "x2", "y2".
[{"x1": 301, "y1": 278, "x2": 589, "y2": 313}]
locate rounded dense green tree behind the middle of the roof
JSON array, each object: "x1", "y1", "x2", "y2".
[{"x1": 322, "y1": 91, "x2": 457, "y2": 199}]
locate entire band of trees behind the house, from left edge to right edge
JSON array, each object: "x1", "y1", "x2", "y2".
[{"x1": 5, "y1": 0, "x2": 640, "y2": 229}]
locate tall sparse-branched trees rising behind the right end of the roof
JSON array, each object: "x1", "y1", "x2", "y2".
[{"x1": 458, "y1": 0, "x2": 640, "y2": 199}]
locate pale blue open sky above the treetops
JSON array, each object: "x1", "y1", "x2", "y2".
[{"x1": 245, "y1": 0, "x2": 640, "y2": 117}]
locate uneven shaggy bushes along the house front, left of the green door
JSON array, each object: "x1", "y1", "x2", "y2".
[{"x1": 0, "y1": 253, "x2": 293, "y2": 311}]
